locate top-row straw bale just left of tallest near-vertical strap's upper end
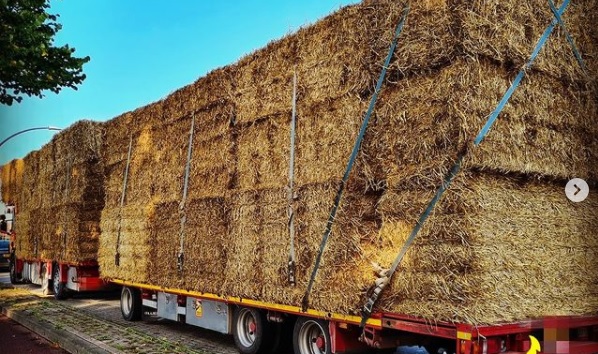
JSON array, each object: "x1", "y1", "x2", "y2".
[{"x1": 234, "y1": 35, "x2": 298, "y2": 123}]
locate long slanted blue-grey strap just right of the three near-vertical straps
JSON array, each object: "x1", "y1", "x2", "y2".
[{"x1": 301, "y1": 5, "x2": 409, "y2": 312}]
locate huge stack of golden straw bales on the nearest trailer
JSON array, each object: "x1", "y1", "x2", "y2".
[{"x1": 99, "y1": 0, "x2": 598, "y2": 323}]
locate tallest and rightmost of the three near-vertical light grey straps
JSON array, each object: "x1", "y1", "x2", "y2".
[{"x1": 287, "y1": 72, "x2": 297, "y2": 285}]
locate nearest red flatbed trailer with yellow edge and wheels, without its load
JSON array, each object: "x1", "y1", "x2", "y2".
[{"x1": 111, "y1": 279, "x2": 598, "y2": 354}]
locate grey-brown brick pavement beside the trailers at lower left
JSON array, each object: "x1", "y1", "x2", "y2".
[{"x1": 0, "y1": 286, "x2": 237, "y2": 354}]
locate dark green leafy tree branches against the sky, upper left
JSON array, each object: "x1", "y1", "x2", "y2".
[{"x1": 0, "y1": 0, "x2": 89, "y2": 106}]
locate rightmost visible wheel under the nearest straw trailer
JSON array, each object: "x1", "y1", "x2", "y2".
[{"x1": 293, "y1": 317, "x2": 331, "y2": 354}]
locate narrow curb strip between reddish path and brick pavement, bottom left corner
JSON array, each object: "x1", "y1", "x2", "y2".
[{"x1": 1, "y1": 307, "x2": 120, "y2": 354}]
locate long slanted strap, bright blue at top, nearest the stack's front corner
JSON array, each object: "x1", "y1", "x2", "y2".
[{"x1": 361, "y1": 0, "x2": 569, "y2": 328}]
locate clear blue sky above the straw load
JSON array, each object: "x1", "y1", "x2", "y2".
[{"x1": 0, "y1": 0, "x2": 359, "y2": 165}]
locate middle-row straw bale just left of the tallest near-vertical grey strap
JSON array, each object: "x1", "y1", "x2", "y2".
[{"x1": 236, "y1": 113, "x2": 291, "y2": 190}]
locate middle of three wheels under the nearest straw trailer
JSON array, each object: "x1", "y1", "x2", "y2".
[{"x1": 233, "y1": 307, "x2": 274, "y2": 354}]
